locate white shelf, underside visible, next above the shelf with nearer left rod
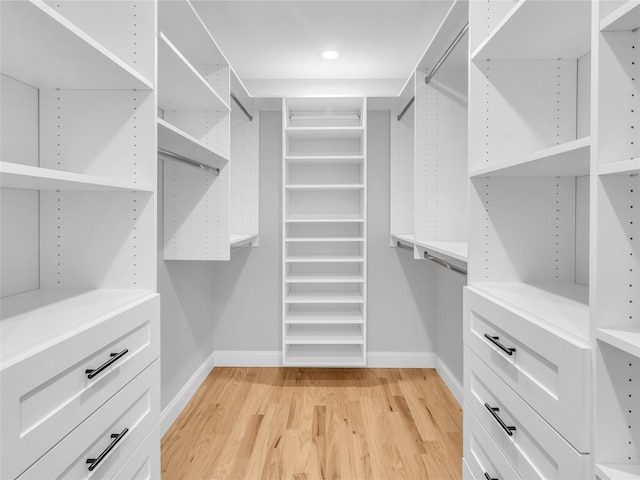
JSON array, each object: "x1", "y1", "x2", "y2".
[{"x1": 158, "y1": 33, "x2": 231, "y2": 112}]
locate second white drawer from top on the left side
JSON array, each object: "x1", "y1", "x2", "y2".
[{"x1": 19, "y1": 360, "x2": 160, "y2": 480}]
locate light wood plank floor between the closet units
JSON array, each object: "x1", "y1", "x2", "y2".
[{"x1": 162, "y1": 368, "x2": 462, "y2": 480}]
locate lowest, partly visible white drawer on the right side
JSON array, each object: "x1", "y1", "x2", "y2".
[{"x1": 464, "y1": 404, "x2": 520, "y2": 480}]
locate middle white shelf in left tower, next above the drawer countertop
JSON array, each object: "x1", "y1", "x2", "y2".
[{"x1": 0, "y1": 162, "x2": 155, "y2": 192}]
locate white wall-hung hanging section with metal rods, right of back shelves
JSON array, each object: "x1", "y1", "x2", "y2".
[{"x1": 390, "y1": 1, "x2": 469, "y2": 270}]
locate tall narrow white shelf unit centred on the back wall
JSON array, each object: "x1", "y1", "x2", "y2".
[{"x1": 282, "y1": 98, "x2": 367, "y2": 367}]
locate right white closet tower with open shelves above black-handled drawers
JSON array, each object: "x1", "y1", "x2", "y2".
[{"x1": 464, "y1": 0, "x2": 593, "y2": 479}]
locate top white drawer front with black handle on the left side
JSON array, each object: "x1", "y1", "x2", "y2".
[{"x1": 0, "y1": 295, "x2": 160, "y2": 478}]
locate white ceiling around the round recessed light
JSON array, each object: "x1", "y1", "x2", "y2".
[{"x1": 193, "y1": 0, "x2": 452, "y2": 96}]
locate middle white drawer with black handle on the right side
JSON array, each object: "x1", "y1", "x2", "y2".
[{"x1": 464, "y1": 347, "x2": 589, "y2": 480}]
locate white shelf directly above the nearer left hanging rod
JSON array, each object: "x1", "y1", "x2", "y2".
[{"x1": 158, "y1": 118, "x2": 229, "y2": 168}]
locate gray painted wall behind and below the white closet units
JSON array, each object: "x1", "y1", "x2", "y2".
[{"x1": 158, "y1": 112, "x2": 462, "y2": 408}]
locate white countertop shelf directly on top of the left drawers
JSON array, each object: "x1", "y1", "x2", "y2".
[{"x1": 0, "y1": 289, "x2": 155, "y2": 367}]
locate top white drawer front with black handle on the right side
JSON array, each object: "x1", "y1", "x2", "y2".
[{"x1": 464, "y1": 288, "x2": 590, "y2": 453}]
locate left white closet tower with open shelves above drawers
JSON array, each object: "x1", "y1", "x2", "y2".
[{"x1": 0, "y1": 0, "x2": 160, "y2": 478}]
